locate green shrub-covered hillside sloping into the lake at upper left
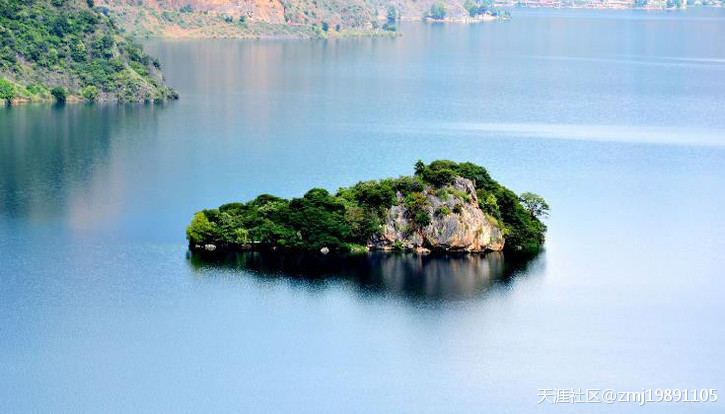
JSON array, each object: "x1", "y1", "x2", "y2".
[{"x1": 0, "y1": 0, "x2": 176, "y2": 102}]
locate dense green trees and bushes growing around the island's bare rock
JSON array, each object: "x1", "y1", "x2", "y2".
[{"x1": 186, "y1": 161, "x2": 548, "y2": 251}]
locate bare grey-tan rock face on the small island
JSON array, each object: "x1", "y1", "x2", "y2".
[{"x1": 368, "y1": 178, "x2": 504, "y2": 252}]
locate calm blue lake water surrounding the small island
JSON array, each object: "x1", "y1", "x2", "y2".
[{"x1": 0, "y1": 8, "x2": 725, "y2": 413}]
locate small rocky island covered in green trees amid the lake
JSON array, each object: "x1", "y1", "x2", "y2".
[{"x1": 186, "y1": 161, "x2": 549, "y2": 253}]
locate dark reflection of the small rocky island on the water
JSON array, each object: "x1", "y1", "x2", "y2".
[{"x1": 187, "y1": 251, "x2": 544, "y2": 300}]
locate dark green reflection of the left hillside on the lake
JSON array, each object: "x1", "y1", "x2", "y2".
[{"x1": 0, "y1": 104, "x2": 164, "y2": 221}]
